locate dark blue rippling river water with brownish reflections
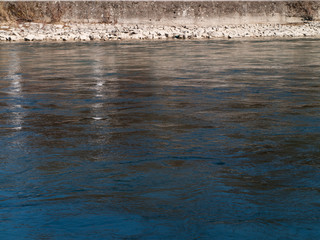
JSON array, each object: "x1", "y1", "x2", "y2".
[{"x1": 0, "y1": 39, "x2": 320, "y2": 240}]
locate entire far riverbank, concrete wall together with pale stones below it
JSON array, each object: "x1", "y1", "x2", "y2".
[{"x1": 0, "y1": 0, "x2": 320, "y2": 41}]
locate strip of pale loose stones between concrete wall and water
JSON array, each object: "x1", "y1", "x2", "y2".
[{"x1": 0, "y1": 22, "x2": 320, "y2": 41}]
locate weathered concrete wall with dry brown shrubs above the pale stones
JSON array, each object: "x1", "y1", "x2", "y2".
[{"x1": 0, "y1": 1, "x2": 320, "y2": 26}]
